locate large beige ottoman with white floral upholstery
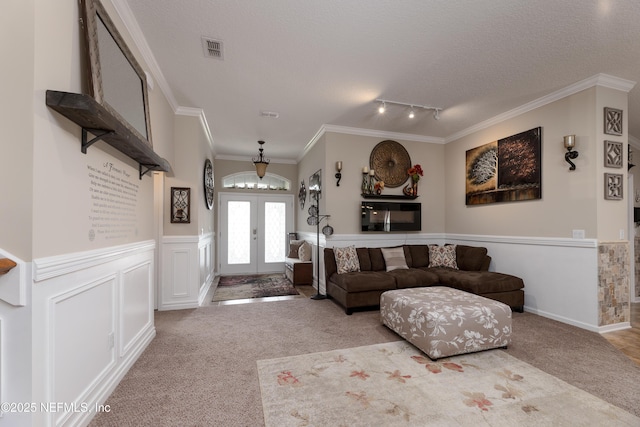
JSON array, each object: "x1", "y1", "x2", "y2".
[{"x1": 380, "y1": 286, "x2": 511, "y2": 359}]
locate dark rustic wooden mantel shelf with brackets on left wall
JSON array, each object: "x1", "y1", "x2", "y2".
[{"x1": 46, "y1": 90, "x2": 171, "y2": 179}]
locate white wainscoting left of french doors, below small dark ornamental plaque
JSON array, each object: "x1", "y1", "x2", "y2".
[{"x1": 158, "y1": 233, "x2": 214, "y2": 310}]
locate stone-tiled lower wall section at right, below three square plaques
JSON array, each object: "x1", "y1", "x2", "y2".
[{"x1": 598, "y1": 242, "x2": 631, "y2": 326}]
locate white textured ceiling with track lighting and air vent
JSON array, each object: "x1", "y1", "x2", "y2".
[{"x1": 120, "y1": 0, "x2": 640, "y2": 160}]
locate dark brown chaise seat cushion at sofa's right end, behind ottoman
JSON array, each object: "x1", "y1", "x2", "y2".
[{"x1": 429, "y1": 267, "x2": 524, "y2": 294}]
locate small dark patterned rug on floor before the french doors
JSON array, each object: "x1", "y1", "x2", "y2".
[{"x1": 212, "y1": 273, "x2": 299, "y2": 301}]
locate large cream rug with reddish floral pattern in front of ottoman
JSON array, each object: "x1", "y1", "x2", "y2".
[{"x1": 257, "y1": 341, "x2": 640, "y2": 427}]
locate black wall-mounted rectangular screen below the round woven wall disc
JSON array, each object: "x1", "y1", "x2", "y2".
[{"x1": 360, "y1": 200, "x2": 422, "y2": 231}]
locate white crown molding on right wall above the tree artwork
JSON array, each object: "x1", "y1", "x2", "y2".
[{"x1": 445, "y1": 74, "x2": 636, "y2": 143}]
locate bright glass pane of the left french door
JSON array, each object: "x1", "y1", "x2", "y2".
[{"x1": 227, "y1": 201, "x2": 251, "y2": 264}]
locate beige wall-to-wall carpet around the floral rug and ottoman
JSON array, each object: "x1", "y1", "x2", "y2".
[{"x1": 90, "y1": 298, "x2": 640, "y2": 427}]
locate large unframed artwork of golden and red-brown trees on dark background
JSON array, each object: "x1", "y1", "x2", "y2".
[{"x1": 465, "y1": 127, "x2": 542, "y2": 205}]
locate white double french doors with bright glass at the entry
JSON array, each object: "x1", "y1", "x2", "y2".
[{"x1": 218, "y1": 193, "x2": 293, "y2": 274}]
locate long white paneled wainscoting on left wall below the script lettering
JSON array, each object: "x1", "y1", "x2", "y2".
[{"x1": 31, "y1": 241, "x2": 155, "y2": 426}]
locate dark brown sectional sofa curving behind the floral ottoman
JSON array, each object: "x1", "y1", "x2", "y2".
[{"x1": 324, "y1": 245, "x2": 524, "y2": 314}]
